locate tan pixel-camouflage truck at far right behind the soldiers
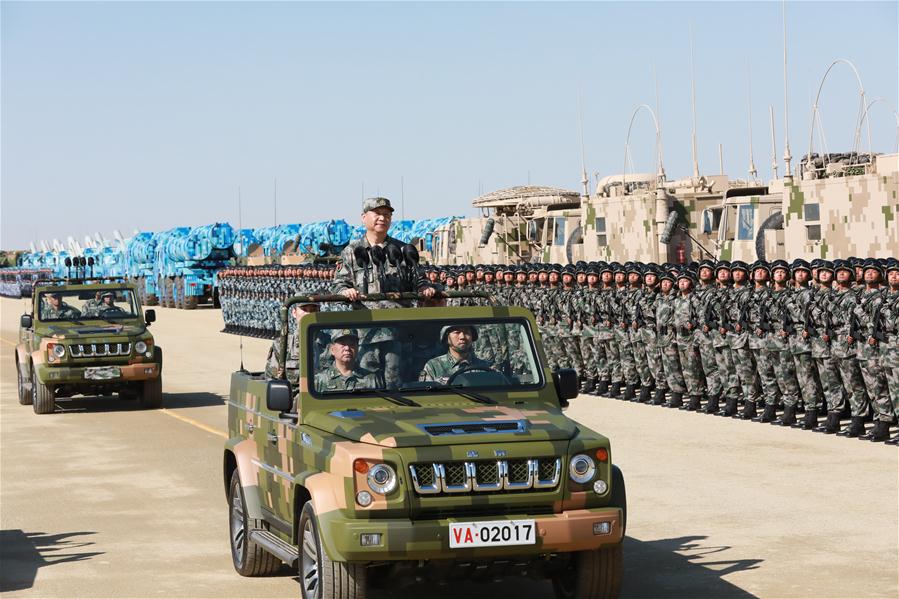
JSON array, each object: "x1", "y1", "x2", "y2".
[{"x1": 703, "y1": 153, "x2": 899, "y2": 261}]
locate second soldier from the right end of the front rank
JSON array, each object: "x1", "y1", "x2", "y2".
[{"x1": 850, "y1": 259, "x2": 893, "y2": 441}]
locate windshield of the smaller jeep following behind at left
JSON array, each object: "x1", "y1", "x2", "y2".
[{"x1": 38, "y1": 287, "x2": 137, "y2": 322}]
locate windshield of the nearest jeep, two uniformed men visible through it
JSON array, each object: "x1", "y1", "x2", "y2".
[{"x1": 306, "y1": 319, "x2": 543, "y2": 403}]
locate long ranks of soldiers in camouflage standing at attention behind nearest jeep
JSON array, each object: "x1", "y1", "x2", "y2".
[{"x1": 222, "y1": 258, "x2": 899, "y2": 444}]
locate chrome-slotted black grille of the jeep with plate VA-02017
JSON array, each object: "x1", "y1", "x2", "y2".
[{"x1": 409, "y1": 457, "x2": 562, "y2": 495}]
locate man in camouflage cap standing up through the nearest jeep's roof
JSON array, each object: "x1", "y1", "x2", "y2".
[{"x1": 334, "y1": 198, "x2": 437, "y2": 308}]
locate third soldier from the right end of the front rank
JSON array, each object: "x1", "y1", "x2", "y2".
[{"x1": 829, "y1": 260, "x2": 870, "y2": 437}]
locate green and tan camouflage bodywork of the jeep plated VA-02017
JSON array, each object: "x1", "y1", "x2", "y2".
[{"x1": 224, "y1": 307, "x2": 625, "y2": 562}]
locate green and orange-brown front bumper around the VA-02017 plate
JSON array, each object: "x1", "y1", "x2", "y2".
[{"x1": 319, "y1": 507, "x2": 623, "y2": 562}]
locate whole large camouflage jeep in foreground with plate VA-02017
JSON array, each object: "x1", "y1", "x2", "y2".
[{"x1": 223, "y1": 298, "x2": 627, "y2": 598}]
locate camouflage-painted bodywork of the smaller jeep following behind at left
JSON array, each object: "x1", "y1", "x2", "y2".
[{"x1": 16, "y1": 281, "x2": 162, "y2": 397}]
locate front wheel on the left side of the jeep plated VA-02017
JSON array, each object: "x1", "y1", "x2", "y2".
[{"x1": 299, "y1": 501, "x2": 367, "y2": 599}]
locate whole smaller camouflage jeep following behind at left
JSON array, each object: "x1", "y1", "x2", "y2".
[{"x1": 16, "y1": 279, "x2": 162, "y2": 414}]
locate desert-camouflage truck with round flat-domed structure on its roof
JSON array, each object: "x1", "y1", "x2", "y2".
[{"x1": 430, "y1": 185, "x2": 584, "y2": 265}]
